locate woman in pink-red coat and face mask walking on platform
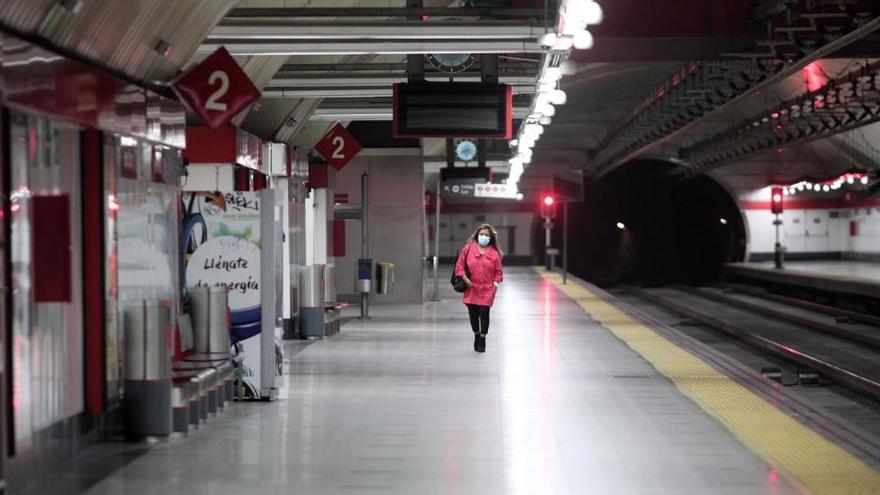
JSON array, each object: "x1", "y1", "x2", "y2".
[{"x1": 455, "y1": 224, "x2": 504, "y2": 352}]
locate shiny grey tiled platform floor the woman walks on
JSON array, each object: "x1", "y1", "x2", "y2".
[{"x1": 90, "y1": 269, "x2": 801, "y2": 495}]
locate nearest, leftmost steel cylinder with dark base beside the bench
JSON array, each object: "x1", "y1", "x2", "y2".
[{"x1": 123, "y1": 301, "x2": 172, "y2": 437}]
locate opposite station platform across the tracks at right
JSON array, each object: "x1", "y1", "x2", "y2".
[{"x1": 725, "y1": 260, "x2": 880, "y2": 298}]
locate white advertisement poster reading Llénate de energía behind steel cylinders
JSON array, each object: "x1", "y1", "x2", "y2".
[{"x1": 180, "y1": 192, "x2": 261, "y2": 397}]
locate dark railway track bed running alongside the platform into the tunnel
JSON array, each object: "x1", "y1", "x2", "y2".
[{"x1": 627, "y1": 286, "x2": 880, "y2": 399}]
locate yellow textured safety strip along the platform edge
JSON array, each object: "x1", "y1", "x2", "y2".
[{"x1": 535, "y1": 268, "x2": 880, "y2": 495}]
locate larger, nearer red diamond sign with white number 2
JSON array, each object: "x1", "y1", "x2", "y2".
[{"x1": 171, "y1": 47, "x2": 260, "y2": 129}]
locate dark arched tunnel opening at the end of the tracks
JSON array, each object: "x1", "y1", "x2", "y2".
[{"x1": 554, "y1": 160, "x2": 746, "y2": 287}]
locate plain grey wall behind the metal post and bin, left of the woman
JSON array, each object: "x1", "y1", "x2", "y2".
[{"x1": 333, "y1": 148, "x2": 425, "y2": 304}]
